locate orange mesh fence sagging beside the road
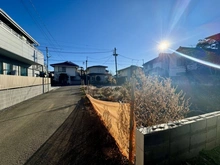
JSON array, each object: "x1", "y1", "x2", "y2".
[{"x1": 87, "y1": 94, "x2": 135, "y2": 161}]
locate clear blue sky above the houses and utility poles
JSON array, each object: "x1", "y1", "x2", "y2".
[{"x1": 0, "y1": 0, "x2": 220, "y2": 73}]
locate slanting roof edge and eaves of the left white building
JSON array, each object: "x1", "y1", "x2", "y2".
[{"x1": 0, "y1": 8, "x2": 40, "y2": 46}]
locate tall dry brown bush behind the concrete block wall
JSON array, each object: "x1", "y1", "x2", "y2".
[{"x1": 128, "y1": 70, "x2": 190, "y2": 127}]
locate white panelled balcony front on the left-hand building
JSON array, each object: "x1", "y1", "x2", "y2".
[{"x1": 0, "y1": 20, "x2": 44, "y2": 65}]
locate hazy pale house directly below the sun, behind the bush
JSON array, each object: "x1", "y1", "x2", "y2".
[{"x1": 143, "y1": 53, "x2": 171, "y2": 77}]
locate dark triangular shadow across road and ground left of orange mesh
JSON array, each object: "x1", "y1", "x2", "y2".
[{"x1": 25, "y1": 98, "x2": 127, "y2": 165}]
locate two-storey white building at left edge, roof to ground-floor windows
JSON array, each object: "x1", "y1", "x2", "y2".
[{"x1": 0, "y1": 9, "x2": 44, "y2": 76}]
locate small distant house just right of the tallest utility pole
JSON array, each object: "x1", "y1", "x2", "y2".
[{"x1": 117, "y1": 65, "x2": 142, "y2": 84}]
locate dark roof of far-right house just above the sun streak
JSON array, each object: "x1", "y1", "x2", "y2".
[{"x1": 176, "y1": 46, "x2": 220, "y2": 64}]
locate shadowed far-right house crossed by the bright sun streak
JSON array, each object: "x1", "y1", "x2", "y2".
[{"x1": 170, "y1": 33, "x2": 220, "y2": 76}]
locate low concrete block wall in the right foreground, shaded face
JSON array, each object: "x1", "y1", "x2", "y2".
[{"x1": 136, "y1": 111, "x2": 220, "y2": 165}]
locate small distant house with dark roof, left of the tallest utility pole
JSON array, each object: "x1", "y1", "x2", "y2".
[{"x1": 87, "y1": 65, "x2": 109, "y2": 84}]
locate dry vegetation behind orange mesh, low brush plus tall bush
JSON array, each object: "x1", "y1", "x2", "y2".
[{"x1": 86, "y1": 70, "x2": 190, "y2": 127}]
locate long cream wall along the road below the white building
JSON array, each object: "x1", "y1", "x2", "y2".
[{"x1": 0, "y1": 84, "x2": 51, "y2": 110}]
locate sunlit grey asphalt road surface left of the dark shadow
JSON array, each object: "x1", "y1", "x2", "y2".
[{"x1": 0, "y1": 86, "x2": 82, "y2": 165}]
